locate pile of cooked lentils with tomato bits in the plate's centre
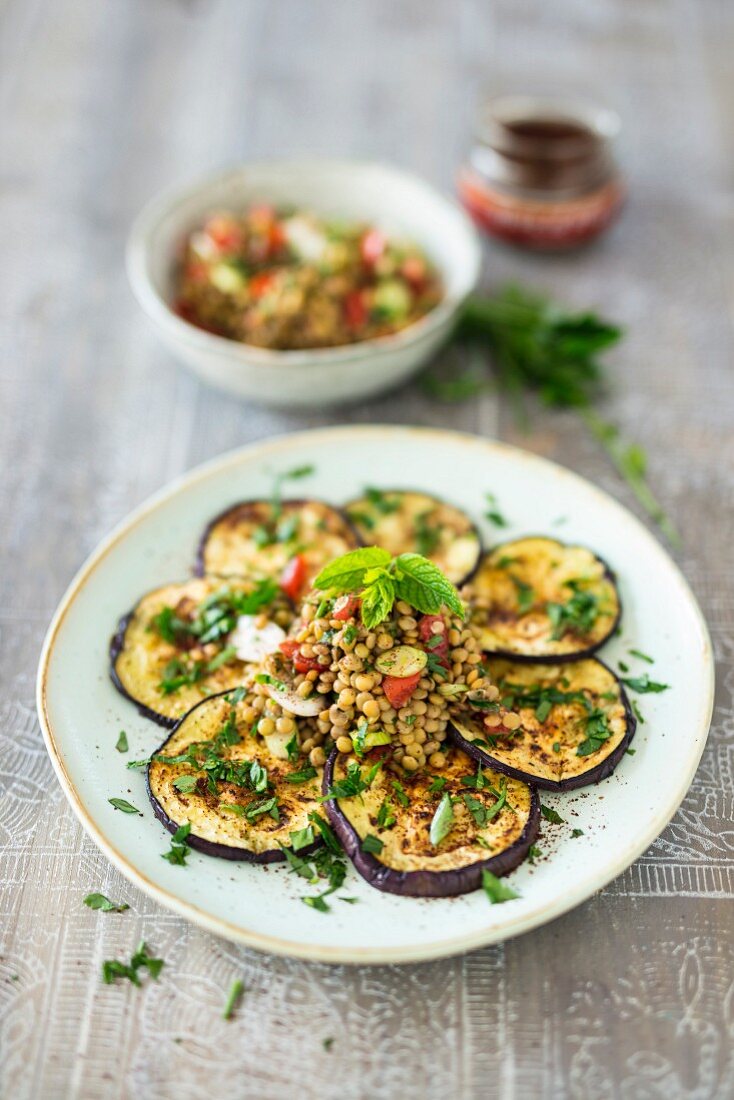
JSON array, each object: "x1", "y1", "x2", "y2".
[{"x1": 253, "y1": 596, "x2": 519, "y2": 772}]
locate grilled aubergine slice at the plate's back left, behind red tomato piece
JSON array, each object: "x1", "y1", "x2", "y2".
[{"x1": 196, "y1": 501, "x2": 360, "y2": 597}]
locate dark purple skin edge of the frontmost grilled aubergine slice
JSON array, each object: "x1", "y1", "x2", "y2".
[{"x1": 322, "y1": 749, "x2": 540, "y2": 898}]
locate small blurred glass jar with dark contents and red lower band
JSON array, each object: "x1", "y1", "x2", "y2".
[{"x1": 458, "y1": 96, "x2": 624, "y2": 250}]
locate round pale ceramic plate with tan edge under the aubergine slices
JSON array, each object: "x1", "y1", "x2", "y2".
[{"x1": 39, "y1": 427, "x2": 713, "y2": 964}]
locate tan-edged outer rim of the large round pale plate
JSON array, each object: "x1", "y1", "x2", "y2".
[{"x1": 36, "y1": 425, "x2": 715, "y2": 966}]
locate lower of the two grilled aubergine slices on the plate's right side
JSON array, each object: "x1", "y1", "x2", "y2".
[{"x1": 450, "y1": 658, "x2": 636, "y2": 791}]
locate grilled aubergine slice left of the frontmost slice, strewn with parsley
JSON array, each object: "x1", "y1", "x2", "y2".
[{"x1": 147, "y1": 693, "x2": 321, "y2": 864}]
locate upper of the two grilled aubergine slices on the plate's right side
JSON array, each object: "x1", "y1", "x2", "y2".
[{"x1": 473, "y1": 537, "x2": 621, "y2": 662}]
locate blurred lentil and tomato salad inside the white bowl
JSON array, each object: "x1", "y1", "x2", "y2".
[{"x1": 176, "y1": 204, "x2": 442, "y2": 351}]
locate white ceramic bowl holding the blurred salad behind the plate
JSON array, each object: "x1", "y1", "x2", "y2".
[{"x1": 127, "y1": 161, "x2": 481, "y2": 406}]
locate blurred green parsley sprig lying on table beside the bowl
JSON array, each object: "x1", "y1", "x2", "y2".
[{"x1": 424, "y1": 286, "x2": 680, "y2": 547}]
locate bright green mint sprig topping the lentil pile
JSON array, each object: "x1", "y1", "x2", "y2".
[{"x1": 314, "y1": 547, "x2": 464, "y2": 629}]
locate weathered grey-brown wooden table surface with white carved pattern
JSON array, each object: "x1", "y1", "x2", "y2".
[{"x1": 0, "y1": 0, "x2": 734, "y2": 1100}]
